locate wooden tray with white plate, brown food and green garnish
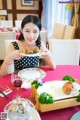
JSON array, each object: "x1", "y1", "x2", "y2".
[{"x1": 31, "y1": 80, "x2": 80, "y2": 112}]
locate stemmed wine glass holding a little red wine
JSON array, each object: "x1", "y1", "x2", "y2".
[{"x1": 11, "y1": 71, "x2": 22, "y2": 98}]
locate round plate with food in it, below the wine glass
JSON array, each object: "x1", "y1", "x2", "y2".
[{"x1": 4, "y1": 98, "x2": 41, "y2": 120}]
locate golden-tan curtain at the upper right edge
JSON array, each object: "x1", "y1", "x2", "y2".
[{"x1": 72, "y1": 0, "x2": 80, "y2": 27}]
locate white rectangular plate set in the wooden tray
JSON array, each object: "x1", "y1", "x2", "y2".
[{"x1": 37, "y1": 80, "x2": 80, "y2": 100}]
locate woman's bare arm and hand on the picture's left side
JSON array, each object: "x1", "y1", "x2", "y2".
[{"x1": 0, "y1": 43, "x2": 23, "y2": 75}]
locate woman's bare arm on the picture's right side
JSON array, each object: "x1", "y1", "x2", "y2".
[{"x1": 41, "y1": 42, "x2": 56, "y2": 69}]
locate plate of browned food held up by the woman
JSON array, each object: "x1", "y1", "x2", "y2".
[{"x1": 24, "y1": 46, "x2": 46, "y2": 57}]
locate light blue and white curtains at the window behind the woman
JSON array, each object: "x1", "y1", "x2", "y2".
[{"x1": 42, "y1": 0, "x2": 72, "y2": 37}]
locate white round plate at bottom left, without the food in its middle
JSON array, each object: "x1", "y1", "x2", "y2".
[{"x1": 4, "y1": 98, "x2": 41, "y2": 120}]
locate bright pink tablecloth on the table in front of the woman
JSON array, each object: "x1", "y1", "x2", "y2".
[{"x1": 0, "y1": 65, "x2": 80, "y2": 120}]
